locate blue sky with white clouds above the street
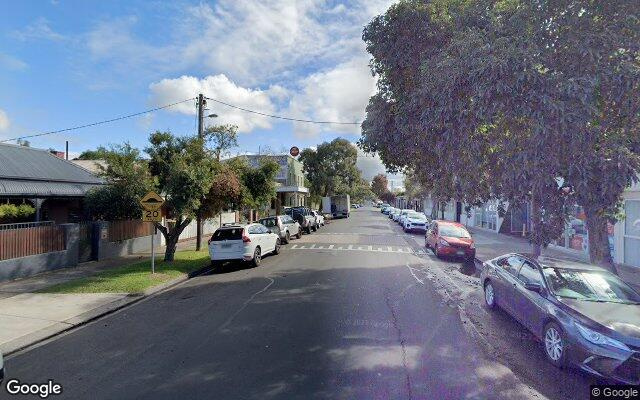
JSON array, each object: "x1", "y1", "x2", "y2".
[{"x1": 0, "y1": 0, "x2": 400, "y2": 187}]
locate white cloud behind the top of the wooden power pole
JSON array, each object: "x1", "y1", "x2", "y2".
[{"x1": 149, "y1": 74, "x2": 286, "y2": 132}]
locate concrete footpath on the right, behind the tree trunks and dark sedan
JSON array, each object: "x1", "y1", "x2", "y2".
[{"x1": 469, "y1": 227, "x2": 640, "y2": 291}]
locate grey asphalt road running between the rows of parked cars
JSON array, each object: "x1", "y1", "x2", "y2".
[{"x1": 0, "y1": 208, "x2": 586, "y2": 399}]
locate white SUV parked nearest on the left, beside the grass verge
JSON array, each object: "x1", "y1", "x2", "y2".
[{"x1": 209, "y1": 224, "x2": 280, "y2": 267}]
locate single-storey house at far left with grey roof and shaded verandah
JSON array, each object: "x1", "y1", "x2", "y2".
[{"x1": 0, "y1": 143, "x2": 104, "y2": 223}]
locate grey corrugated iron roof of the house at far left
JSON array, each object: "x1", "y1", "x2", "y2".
[{"x1": 0, "y1": 143, "x2": 103, "y2": 184}]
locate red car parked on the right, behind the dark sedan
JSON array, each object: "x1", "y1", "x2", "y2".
[{"x1": 424, "y1": 220, "x2": 476, "y2": 260}]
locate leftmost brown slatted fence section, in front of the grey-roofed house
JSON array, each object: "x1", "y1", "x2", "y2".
[{"x1": 0, "y1": 225, "x2": 65, "y2": 260}]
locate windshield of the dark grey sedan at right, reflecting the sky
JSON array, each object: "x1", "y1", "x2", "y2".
[{"x1": 543, "y1": 267, "x2": 640, "y2": 304}]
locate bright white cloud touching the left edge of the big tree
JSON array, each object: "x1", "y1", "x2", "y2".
[{"x1": 288, "y1": 57, "x2": 375, "y2": 136}]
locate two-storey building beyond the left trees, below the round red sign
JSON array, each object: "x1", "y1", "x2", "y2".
[{"x1": 231, "y1": 154, "x2": 309, "y2": 213}]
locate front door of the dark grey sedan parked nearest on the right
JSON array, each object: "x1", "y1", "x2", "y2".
[{"x1": 513, "y1": 259, "x2": 546, "y2": 333}]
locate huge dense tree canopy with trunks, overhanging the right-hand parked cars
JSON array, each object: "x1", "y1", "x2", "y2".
[{"x1": 360, "y1": 0, "x2": 640, "y2": 262}]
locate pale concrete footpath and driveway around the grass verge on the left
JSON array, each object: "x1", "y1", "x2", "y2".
[{"x1": 0, "y1": 240, "x2": 201, "y2": 355}]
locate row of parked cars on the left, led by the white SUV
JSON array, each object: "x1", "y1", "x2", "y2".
[{"x1": 208, "y1": 207, "x2": 325, "y2": 267}]
